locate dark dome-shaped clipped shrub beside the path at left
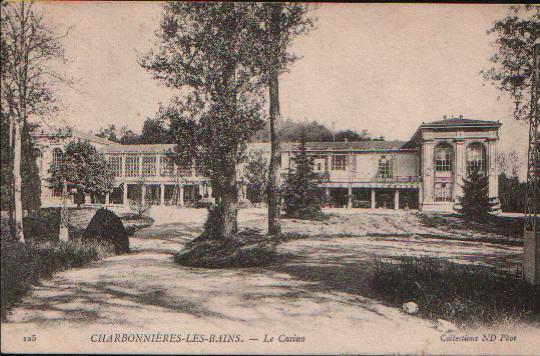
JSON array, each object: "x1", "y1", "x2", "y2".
[{"x1": 83, "y1": 208, "x2": 129, "y2": 255}]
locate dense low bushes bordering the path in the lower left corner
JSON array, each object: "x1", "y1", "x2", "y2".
[{"x1": 1, "y1": 239, "x2": 112, "y2": 320}]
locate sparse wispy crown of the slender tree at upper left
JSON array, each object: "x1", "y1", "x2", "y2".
[{"x1": 0, "y1": 1, "x2": 72, "y2": 120}]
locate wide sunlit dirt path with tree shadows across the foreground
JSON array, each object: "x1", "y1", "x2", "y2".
[{"x1": 2, "y1": 211, "x2": 536, "y2": 353}]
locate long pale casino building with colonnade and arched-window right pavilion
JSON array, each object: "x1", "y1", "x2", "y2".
[{"x1": 31, "y1": 117, "x2": 501, "y2": 211}]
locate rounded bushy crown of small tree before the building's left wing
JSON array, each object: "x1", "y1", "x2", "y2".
[{"x1": 48, "y1": 140, "x2": 114, "y2": 206}]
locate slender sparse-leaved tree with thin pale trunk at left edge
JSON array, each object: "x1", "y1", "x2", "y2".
[{"x1": 0, "y1": 1, "x2": 67, "y2": 242}]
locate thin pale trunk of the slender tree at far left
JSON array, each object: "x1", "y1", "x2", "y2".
[{"x1": 13, "y1": 119, "x2": 25, "y2": 242}]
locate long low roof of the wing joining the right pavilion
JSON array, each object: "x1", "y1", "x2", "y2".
[{"x1": 282, "y1": 141, "x2": 407, "y2": 151}]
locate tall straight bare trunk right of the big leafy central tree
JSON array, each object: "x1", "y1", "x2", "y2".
[{"x1": 267, "y1": 3, "x2": 283, "y2": 235}]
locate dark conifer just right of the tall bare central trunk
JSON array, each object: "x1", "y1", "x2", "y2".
[{"x1": 283, "y1": 133, "x2": 324, "y2": 219}]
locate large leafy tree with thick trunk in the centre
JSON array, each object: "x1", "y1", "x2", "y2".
[{"x1": 141, "y1": 2, "x2": 274, "y2": 238}]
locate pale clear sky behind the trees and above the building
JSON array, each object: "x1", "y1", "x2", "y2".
[{"x1": 39, "y1": 1, "x2": 528, "y2": 170}]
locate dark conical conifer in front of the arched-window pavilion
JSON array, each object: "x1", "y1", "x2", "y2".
[{"x1": 458, "y1": 165, "x2": 497, "y2": 222}]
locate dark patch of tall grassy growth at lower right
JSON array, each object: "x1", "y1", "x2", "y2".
[{"x1": 372, "y1": 258, "x2": 540, "y2": 327}]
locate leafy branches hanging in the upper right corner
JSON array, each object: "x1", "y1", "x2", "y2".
[{"x1": 481, "y1": 5, "x2": 540, "y2": 120}]
